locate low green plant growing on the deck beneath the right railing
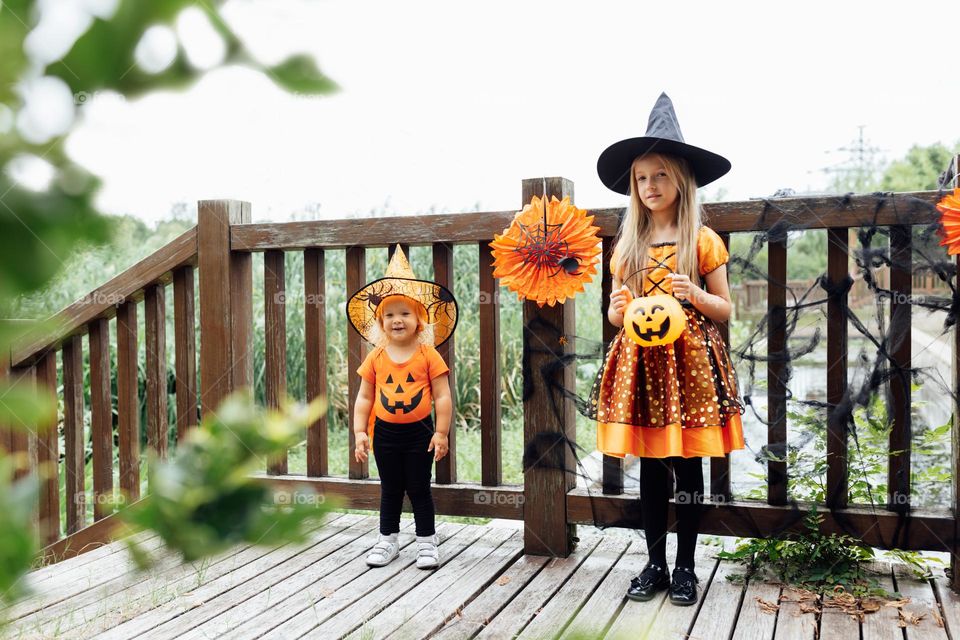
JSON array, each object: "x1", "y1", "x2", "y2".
[{"x1": 717, "y1": 507, "x2": 882, "y2": 596}]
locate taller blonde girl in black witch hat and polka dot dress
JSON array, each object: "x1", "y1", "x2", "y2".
[{"x1": 591, "y1": 94, "x2": 744, "y2": 605}]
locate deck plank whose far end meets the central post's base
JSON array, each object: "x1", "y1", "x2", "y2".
[{"x1": 430, "y1": 556, "x2": 549, "y2": 640}]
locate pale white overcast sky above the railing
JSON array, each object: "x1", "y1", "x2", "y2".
[{"x1": 58, "y1": 0, "x2": 960, "y2": 221}]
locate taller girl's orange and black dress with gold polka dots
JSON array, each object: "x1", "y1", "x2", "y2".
[{"x1": 589, "y1": 227, "x2": 744, "y2": 458}]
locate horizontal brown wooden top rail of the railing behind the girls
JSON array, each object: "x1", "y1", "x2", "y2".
[{"x1": 231, "y1": 191, "x2": 941, "y2": 251}]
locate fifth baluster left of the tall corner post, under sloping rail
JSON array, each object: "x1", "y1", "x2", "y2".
[{"x1": 63, "y1": 336, "x2": 87, "y2": 535}]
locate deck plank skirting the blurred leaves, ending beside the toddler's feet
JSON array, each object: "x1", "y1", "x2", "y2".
[{"x1": 87, "y1": 514, "x2": 352, "y2": 638}]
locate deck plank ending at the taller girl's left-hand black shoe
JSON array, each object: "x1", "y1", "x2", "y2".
[{"x1": 561, "y1": 540, "x2": 647, "y2": 640}]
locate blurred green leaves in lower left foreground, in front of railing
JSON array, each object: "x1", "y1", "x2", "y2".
[{"x1": 121, "y1": 395, "x2": 332, "y2": 565}]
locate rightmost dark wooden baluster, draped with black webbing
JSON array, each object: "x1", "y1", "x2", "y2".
[{"x1": 887, "y1": 226, "x2": 913, "y2": 513}]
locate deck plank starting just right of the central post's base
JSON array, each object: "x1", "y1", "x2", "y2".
[{"x1": 477, "y1": 538, "x2": 600, "y2": 638}]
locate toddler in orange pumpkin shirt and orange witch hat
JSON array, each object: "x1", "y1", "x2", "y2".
[{"x1": 347, "y1": 246, "x2": 457, "y2": 569}]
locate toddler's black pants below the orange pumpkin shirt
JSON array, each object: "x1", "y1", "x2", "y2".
[{"x1": 373, "y1": 417, "x2": 436, "y2": 536}]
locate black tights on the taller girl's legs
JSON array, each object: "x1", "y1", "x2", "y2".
[{"x1": 640, "y1": 458, "x2": 703, "y2": 569}]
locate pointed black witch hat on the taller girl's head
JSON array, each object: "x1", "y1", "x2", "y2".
[{"x1": 597, "y1": 93, "x2": 730, "y2": 195}]
